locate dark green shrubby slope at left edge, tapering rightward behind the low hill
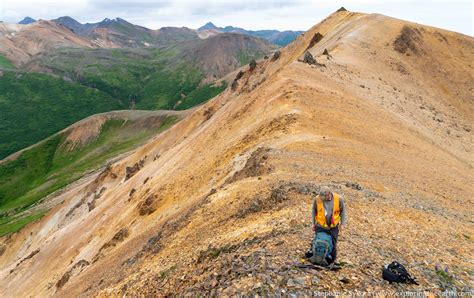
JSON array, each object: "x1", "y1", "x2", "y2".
[{"x1": 0, "y1": 71, "x2": 125, "y2": 159}]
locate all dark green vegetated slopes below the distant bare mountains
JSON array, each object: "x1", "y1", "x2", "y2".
[{"x1": 0, "y1": 49, "x2": 226, "y2": 159}]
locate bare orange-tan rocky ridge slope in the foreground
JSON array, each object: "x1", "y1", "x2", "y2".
[{"x1": 0, "y1": 12, "x2": 474, "y2": 297}]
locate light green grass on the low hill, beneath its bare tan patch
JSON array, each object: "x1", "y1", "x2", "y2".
[{"x1": 0, "y1": 117, "x2": 177, "y2": 236}]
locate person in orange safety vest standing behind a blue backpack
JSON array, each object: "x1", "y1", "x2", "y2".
[{"x1": 311, "y1": 186, "x2": 347, "y2": 263}]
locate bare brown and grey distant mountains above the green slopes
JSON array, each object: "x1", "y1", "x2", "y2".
[{"x1": 0, "y1": 17, "x2": 276, "y2": 80}]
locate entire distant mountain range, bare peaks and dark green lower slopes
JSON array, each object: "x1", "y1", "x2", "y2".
[{"x1": 0, "y1": 17, "x2": 276, "y2": 159}]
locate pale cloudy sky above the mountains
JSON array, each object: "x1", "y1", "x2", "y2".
[{"x1": 0, "y1": 0, "x2": 474, "y2": 36}]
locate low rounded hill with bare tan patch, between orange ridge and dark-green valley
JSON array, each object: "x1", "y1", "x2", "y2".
[{"x1": 0, "y1": 111, "x2": 187, "y2": 235}]
